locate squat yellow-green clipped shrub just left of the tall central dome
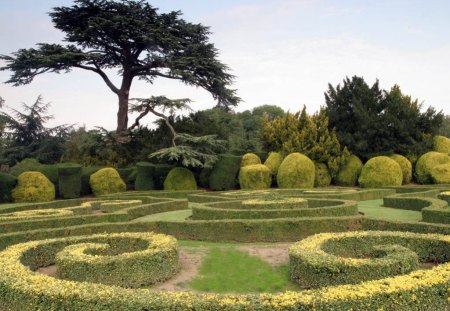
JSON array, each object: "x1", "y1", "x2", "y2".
[{"x1": 239, "y1": 164, "x2": 272, "y2": 189}]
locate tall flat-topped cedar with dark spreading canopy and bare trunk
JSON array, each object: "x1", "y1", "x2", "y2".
[{"x1": 0, "y1": 0, "x2": 240, "y2": 133}]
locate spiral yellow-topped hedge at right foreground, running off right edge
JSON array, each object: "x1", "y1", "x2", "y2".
[{"x1": 289, "y1": 231, "x2": 450, "y2": 287}]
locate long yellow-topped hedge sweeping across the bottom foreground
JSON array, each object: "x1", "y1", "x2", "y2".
[{"x1": 0, "y1": 233, "x2": 450, "y2": 311}]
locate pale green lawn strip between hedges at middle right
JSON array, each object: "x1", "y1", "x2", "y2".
[{"x1": 358, "y1": 200, "x2": 422, "y2": 221}]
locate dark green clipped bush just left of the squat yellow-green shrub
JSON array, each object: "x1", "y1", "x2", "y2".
[{"x1": 209, "y1": 154, "x2": 241, "y2": 190}]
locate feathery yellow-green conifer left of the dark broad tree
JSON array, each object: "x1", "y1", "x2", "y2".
[{"x1": 262, "y1": 107, "x2": 350, "y2": 176}]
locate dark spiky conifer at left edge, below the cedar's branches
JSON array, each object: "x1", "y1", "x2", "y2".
[{"x1": 0, "y1": 96, "x2": 72, "y2": 165}]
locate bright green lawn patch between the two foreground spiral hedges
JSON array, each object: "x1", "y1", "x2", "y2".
[{"x1": 186, "y1": 248, "x2": 298, "y2": 293}]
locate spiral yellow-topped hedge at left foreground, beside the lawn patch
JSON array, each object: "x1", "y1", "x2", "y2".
[{"x1": 54, "y1": 233, "x2": 178, "y2": 288}]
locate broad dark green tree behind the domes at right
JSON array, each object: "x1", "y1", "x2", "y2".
[{"x1": 325, "y1": 76, "x2": 443, "y2": 161}]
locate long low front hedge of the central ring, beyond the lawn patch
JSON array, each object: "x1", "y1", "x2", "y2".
[{"x1": 192, "y1": 199, "x2": 358, "y2": 220}]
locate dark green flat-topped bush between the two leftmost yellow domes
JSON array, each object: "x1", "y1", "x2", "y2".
[{"x1": 58, "y1": 163, "x2": 82, "y2": 199}]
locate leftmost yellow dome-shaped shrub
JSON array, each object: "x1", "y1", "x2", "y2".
[{"x1": 12, "y1": 172, "x2": 55, "y2": 202}]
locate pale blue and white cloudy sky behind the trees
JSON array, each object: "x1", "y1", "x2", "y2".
[{"x1": 0, "y1": 0, "x2": 450, "y2": 130}]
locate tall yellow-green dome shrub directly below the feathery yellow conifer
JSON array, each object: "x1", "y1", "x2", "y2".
[{"x1": 277, "y1": 152, "x2": 316, "y2": 188}]
